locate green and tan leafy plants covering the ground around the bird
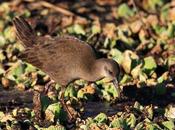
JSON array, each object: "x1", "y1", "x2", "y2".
[{"x1": 0, "y1": 0, "x2": 175, "y2": 130}]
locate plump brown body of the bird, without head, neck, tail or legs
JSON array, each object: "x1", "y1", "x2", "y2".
[{"x1": 21, "y1": 36, "x2": 96, "y2": 85}]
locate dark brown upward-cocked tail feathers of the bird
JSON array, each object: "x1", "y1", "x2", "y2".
[{"x1": 13, "y1": 17, "x2": 37, "y2": 47}]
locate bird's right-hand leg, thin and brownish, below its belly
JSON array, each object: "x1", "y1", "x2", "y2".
[{"x1": 60, "y1": 87, "x2": 73, "y2": 121}]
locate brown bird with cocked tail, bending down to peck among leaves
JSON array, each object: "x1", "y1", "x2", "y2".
[{"x1": 13, "y1": 17, "x2": 120, "y2": 119}]
